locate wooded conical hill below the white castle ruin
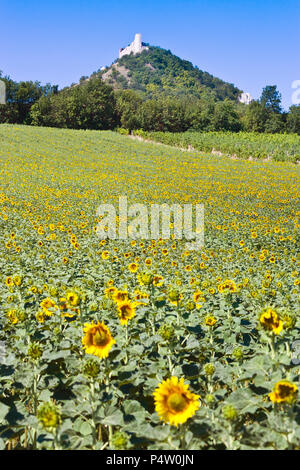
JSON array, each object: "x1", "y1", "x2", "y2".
[{"x1": 99, "y1": 46, "x2": 241, "y2": 101}]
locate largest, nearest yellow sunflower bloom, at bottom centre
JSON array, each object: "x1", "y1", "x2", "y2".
[{"x1": 153, "y1": 377, "x2": 200, "y2": 426}]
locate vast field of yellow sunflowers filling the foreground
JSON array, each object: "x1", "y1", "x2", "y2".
[{"x1": 0, "y1": 125, "x2": 300, "y2": 450}]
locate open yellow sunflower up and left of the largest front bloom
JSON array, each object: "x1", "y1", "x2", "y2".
[{"x1": 82, "y1": 322, "x2": 115, "y2": 359}]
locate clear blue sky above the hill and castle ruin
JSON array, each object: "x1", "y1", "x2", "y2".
[{"x1": 0, "y1": 0, "x2": 300, "y2": 108}]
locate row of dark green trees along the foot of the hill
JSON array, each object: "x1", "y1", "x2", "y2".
[{"x1": 0, "y1": 72, "x2": 300, "y2": 134}]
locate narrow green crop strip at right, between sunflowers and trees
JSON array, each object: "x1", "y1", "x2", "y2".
[{"x1": 135, "y1": 131, "x2": 300, "y2": 163}]
